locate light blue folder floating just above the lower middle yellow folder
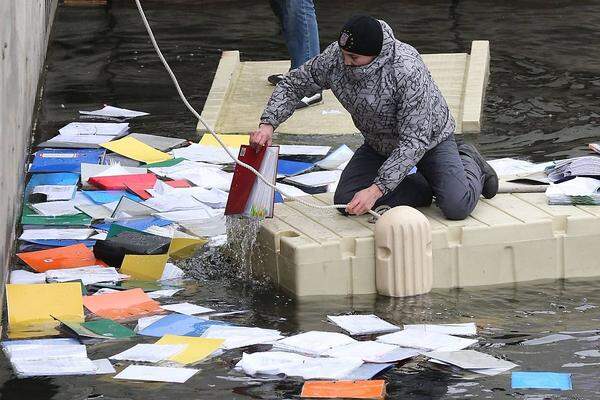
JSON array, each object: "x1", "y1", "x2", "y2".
[{"x1": 139, "y1": 314, "x2": 231, "y2": 337}]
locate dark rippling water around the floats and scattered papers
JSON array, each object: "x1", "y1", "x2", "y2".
[{"x1": 8, "y1": 0, "x2": 600, "y2": 400}]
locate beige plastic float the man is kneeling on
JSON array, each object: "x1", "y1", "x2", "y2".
[{"x1": 253, "y1": 193, "x2": 600, "y2": 296}]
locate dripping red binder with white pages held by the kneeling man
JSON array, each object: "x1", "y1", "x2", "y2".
[{"x1": 225, "y1": 146, "x2": 279, "y2": 218}]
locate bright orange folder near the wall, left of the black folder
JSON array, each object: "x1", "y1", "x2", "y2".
[{"x1": 17, "y1": 243, "x2": 106, "y2": 272}]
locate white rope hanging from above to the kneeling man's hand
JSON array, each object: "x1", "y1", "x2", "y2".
[{"x1": 135, "y1": 0, "x2": 380, "y2": 218}]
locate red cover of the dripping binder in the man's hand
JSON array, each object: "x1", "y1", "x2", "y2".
[{"x1": 225, "y1": 145, "x2": 267, "y2": 215}]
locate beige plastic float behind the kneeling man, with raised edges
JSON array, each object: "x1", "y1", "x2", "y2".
[{"x1": 197, "y1": 41, "x2": 490, "y2": 135}]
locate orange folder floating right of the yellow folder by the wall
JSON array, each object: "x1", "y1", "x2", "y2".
[{"x1": 83, "y1": 288, "x2": 163, "y2": 320}]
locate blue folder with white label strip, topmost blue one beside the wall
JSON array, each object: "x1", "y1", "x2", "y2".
[{"x1": 29, "y1": 149, "x2": 104, "y2": 172}]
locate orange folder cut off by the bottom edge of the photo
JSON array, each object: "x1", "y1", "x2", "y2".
[{"x1": 300, "y1": 380, "x2": 385, "y2": 400}]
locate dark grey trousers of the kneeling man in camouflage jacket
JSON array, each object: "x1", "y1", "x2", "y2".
[{"x1": 334, "y1": 135, "x2": 484, "y2": 220}]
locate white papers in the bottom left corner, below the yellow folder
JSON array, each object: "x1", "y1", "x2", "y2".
[{"x1": 2, "y1": 339, "x2": 115, "y2": 378}]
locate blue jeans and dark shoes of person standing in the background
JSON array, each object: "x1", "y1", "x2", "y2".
[{"x1": 268, "y1": 0, "x2": 323, "y2": 109}]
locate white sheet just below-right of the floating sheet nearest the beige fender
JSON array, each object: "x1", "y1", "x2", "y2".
[{"x1": 377, "y1": 329, "x2": 477, "y2": 351}]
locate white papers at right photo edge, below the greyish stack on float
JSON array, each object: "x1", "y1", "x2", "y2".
[{"x1": 546, "y1": 176, "x2": 600, "y2": 205}]
